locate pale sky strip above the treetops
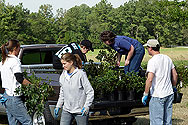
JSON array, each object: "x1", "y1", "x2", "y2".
[{"x1": 5, "y1": 0, "x2": 128, "y2": 14}]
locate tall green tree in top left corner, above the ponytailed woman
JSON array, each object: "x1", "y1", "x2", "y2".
[{"x1": 0, "y1": 1, "x2": 29, "y2": 42}]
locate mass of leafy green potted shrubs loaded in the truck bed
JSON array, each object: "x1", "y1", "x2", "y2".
[{"x1": 84, "y1": 49, "x2": 145, "y2": 99}]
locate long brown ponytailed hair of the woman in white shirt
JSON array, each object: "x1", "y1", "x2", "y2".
[{"x1": 1, "y1": 40, "x2": 20, "y2": 64}]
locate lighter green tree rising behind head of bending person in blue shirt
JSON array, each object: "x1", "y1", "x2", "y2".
[{"x1": 87, "y1": 0, "x2": 113, "y2": 48}]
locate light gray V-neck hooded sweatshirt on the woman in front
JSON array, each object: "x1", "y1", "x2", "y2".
[{"x1": 56, "y1": 68, "x2": 94, "y2": 114}]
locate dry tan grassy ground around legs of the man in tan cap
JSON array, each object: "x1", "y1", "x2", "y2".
[{"x1": 133, "y1": 88, "x2": 188, "y2": 125}]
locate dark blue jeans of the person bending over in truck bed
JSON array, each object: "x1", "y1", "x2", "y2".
[{"x1": 124, "y1": 42, "x2": 145, "y2": 74}]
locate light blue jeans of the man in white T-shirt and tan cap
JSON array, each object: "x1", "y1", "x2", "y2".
[{"x1": 149, "y1": 94, "x2": 174, "y2": 125}]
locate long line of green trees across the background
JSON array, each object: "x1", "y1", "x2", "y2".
[{"x1": 0, "y1": 0, "x2": 188, "y2": 48}]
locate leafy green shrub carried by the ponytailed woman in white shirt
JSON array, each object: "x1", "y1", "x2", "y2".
[{"x1": 16, "y1": 72, "x2": 54, "y2": 115}]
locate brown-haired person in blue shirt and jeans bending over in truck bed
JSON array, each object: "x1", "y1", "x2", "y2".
[{"x1": 100, "y1": 31, "x2": 145, "y2": 73}]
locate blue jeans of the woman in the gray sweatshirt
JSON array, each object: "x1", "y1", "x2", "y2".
[{"x1": 60, "y1": 110, "x2": 89, "y2": 125}]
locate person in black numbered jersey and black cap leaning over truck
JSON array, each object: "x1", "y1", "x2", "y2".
[{"x1": 53, "y1": 40, "x2": 94, "y2": 69}]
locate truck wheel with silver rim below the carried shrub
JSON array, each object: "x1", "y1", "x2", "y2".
[{"x1": 33, "y1": 102, "x2": 56, "y2": 125}]
